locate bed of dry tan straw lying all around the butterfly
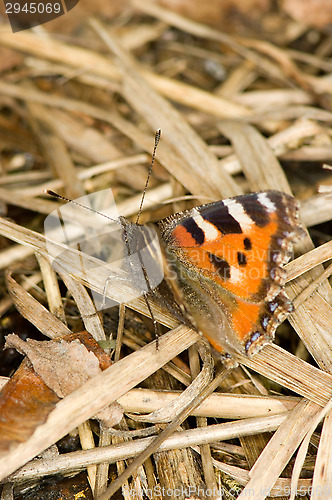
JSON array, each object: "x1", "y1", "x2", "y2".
[{"x1": 0, "y1": 1, "x2": 332, "y2": 499}]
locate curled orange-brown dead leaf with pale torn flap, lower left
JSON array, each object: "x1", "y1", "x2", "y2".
[{"x1": 0, "y1": 332, "x2": 122, "y2": 453}]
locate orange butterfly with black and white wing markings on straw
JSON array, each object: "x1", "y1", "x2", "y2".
[{"x1": 122, "y1": 191, "x2": 304, "y2": 364}]
